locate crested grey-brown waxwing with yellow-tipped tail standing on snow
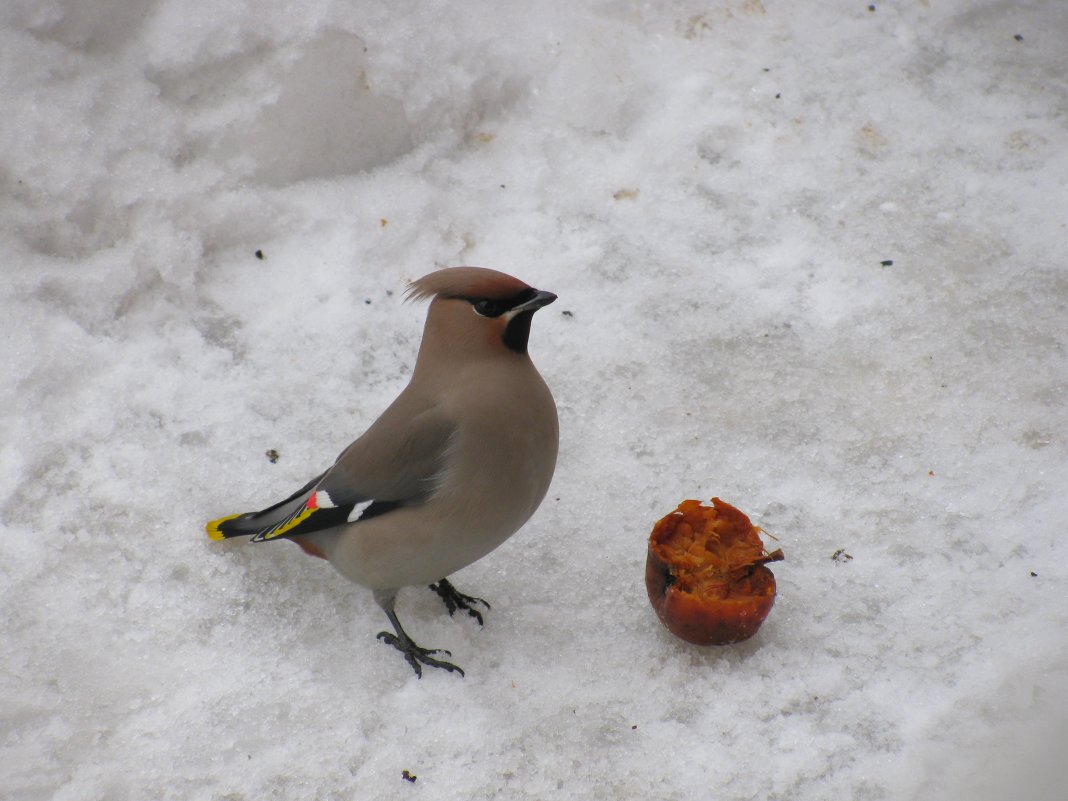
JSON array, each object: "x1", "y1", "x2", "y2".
[{"x1": 206, "y1": 267, "x2": 560, "y2": 678}]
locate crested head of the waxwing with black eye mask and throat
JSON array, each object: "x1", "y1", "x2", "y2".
[{"x1": 408, "y1": 267, "x2": 556, "y2": 357}]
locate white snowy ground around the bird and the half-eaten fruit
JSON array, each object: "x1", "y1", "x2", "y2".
[{"x1": 0, "y1": 0, "x2": 1068, "y2": 801}]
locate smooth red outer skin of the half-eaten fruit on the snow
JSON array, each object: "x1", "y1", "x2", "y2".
[{"x1": 645, "y1": 544, "x2": 775, "y2": 645}]
